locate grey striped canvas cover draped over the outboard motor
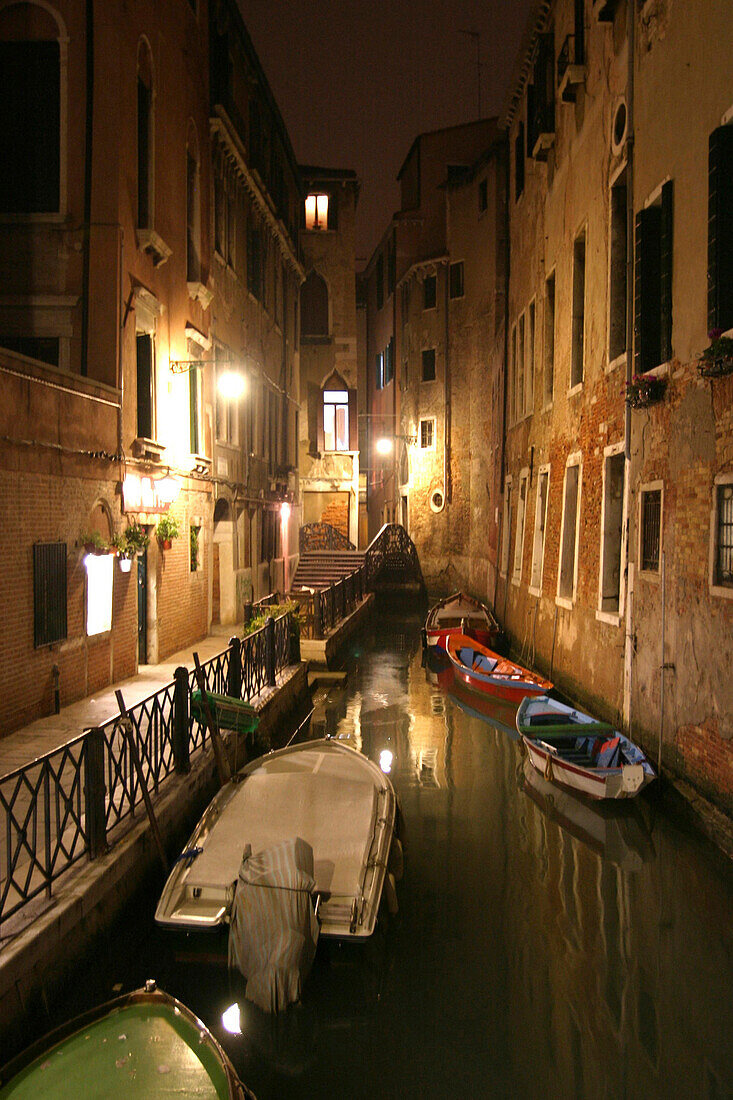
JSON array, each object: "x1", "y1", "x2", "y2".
[{"x1": 229, "y1": 837, "x2": 318, "y2": 1012}]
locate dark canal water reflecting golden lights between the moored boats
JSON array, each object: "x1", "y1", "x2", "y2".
[{"x1": 9, "y1": 617, "x2": 733, "y2": 1100}]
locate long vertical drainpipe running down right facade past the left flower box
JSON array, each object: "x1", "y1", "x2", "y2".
[{"x1": 623, "y1": 2, "x2": 636, "y2": 729}]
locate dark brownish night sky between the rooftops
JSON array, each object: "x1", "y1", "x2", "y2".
[{"x1": 239, "y1": 0, "x2": 530, "y2": 266}]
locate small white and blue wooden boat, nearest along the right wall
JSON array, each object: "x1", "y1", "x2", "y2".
[{"x1": 516, "y1": 696, "x2": 656, "y2": 799}]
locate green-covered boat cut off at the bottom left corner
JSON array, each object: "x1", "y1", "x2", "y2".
[{"x1": 0, "y1": 981, "x2": 254, "y2": 1100}]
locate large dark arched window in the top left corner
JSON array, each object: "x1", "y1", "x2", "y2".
[{"x1": 0, "y1": 2, "x2": 66, "y2": 215}]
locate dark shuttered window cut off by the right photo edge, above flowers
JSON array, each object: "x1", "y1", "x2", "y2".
[{"x1": 708, "y1": 123, "x2": 733, "y2": 332}]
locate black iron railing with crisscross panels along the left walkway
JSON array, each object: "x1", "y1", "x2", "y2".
[{"x1": 0, "y1": 612, "x2": 300, "y2": 934}]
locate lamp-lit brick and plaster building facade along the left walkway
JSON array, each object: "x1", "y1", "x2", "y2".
[{"x1": 0, "y1": 0, "x2": 303, "y2": 735}]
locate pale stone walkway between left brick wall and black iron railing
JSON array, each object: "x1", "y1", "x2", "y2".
[{"x1": 0, "y1": 625, "x2": 237, "y2": 778}]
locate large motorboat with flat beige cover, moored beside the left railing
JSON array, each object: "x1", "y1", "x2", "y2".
[{"x1": 155, "y1": 738, "x2": 396, "y2": 938}]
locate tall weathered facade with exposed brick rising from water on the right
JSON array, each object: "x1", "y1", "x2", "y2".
[{"x1": 496, "y1": 0, "x2": 733, "y2": 809}]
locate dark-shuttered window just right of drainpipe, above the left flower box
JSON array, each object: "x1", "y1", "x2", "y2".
[{"x1": 634, "y1": 180, "x2": 674, "y2": 374}]
